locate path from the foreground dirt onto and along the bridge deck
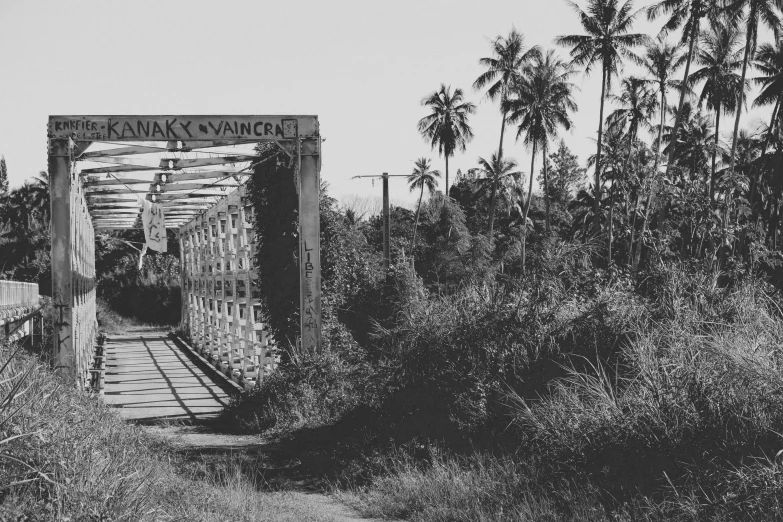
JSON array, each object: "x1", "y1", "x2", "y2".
[{"x1": 104, "y1": 328, "x2": 390, "y2": 522}]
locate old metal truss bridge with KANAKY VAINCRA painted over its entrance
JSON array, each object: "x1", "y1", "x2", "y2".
[{"x1": 0, "y1": 115, "x2": 321, "y2": 410}]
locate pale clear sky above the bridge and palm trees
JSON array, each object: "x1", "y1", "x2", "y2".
[{"x1": 0, "y1": 0, "x2": 772, "y2": 207}]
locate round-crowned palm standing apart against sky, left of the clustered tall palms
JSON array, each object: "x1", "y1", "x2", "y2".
[{"x1": 418, "y1": 84, "x2": 476, "y2": 198}]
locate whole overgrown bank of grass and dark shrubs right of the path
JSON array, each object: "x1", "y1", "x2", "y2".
[{"x1": 217, "y1": 263, "x2": 783, "y2": 522}]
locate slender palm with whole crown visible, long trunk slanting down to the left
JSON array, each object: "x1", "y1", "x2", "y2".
[{"x1": 629, "y1": 35, "x2": 687, "y2": 267}]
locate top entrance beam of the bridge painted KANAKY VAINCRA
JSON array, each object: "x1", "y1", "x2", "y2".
[{"x1": 48, "y1": 116, "x2": 318, "y2": 143}]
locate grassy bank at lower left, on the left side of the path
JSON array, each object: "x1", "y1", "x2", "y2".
[{"x1": 0, "y1": 336, "x2": 352, "y2": 522}]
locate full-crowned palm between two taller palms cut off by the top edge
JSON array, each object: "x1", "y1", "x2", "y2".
[{"x1": 688, "y1": 22, "x2": 744, "y2": 205}]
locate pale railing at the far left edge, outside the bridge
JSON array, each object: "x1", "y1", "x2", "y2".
[{"x1": 0, "y1": 281, "x2": 43, "y2": 341}]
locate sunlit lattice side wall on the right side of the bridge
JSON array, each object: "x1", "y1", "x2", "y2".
[{"x1": 179, "y1": 187, "x2": 278, "y2": 389}]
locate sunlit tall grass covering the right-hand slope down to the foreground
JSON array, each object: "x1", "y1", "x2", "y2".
[{"x1": 346, "y1": 273, "x2": 783, "y2": 522}]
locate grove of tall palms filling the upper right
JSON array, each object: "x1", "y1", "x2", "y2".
[{"x1": 416, "y1": 0, "x2": 783, "y2": 276}]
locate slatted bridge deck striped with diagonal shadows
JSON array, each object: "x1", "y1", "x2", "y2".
[{"x1": 104, "y1": 328, "x2": 228, "y2": 422}]
